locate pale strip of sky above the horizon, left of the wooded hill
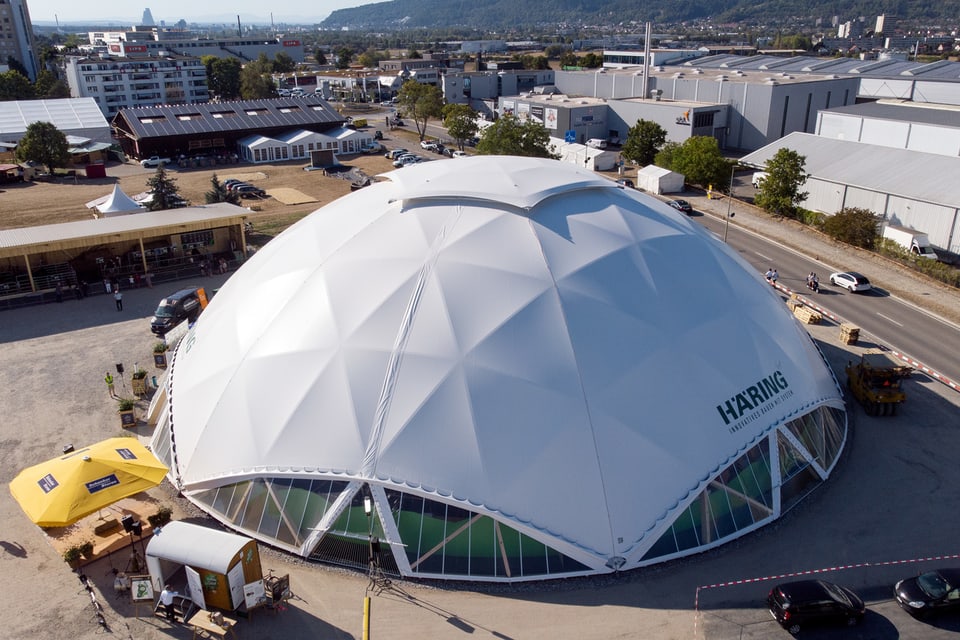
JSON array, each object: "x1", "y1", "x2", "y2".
[{"x1": 27, "y1": 0, "x2": 382, "y2": 25}]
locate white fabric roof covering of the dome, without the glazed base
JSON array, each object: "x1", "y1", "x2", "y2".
[{"x1": 161, "y1": 157, "x2": 841, "y2": 558}]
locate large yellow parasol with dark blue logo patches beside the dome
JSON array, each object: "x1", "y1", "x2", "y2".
[{"x1": 10, "y1": 438, "x2": 167, "y2": 527}]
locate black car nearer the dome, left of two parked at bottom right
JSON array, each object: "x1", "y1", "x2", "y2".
[{"x1": 767, "y1": 580, "x2": 866, "y2": 635}]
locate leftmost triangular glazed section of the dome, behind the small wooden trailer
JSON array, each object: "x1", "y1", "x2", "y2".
[{"x1": 190, "y1": 478, "x2": 348, "y2": 547}]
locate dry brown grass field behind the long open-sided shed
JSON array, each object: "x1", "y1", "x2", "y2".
[{"x1": 0, "y1": 148, "x2": 402, "y2": 240}]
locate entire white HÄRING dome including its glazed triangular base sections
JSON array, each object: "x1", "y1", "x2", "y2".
[{"x1": 153, "y1": 156, "x2": 847, "y2": 581}]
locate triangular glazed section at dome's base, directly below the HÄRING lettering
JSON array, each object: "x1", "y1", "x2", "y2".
[{"x1": 643, "y1": 438, "x2": 773, "y2": 560}]
